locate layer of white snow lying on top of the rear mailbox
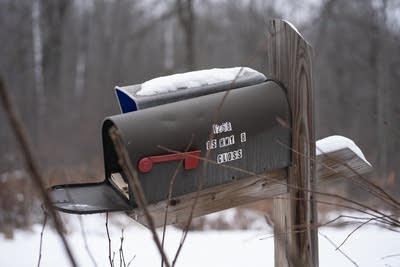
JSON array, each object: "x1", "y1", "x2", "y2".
[{"x1": 136, "y1": 67, "x2": 267, "y2": 96}]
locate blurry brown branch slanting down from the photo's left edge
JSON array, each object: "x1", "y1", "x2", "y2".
[{"x1": 0, "y1": 77, "x2": 77, "y2": 267}]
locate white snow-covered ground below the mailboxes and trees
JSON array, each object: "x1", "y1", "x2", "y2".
[{"x1": 0, "y1": 210, "x2": 400, "y2": 267}]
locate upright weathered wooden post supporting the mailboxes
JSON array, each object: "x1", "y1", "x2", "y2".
[{"x1": 267, "y1": 20, "x2": 318, "y2": 267}]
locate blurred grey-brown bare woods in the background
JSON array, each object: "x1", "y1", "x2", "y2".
[{"x1": 0, "y1": 0, "x2": 400, "y2": 191}]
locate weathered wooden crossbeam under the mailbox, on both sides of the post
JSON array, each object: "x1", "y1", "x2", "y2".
[{"x1": 128, "y1": 149, "x2": 371, "y2": 228}]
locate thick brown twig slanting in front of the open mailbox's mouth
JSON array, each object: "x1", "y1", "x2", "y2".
[{"x1": 109, "y1": 127, "x2": 171, "y2": 267}]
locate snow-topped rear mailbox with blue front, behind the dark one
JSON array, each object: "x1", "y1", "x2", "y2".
[{"x1": 115, "y1": 67, "x2": 267, "y2": 113}]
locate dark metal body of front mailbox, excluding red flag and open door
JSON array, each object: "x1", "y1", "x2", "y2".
[{"x1": 103, "y1": 81, "x2": 291, "y2": 206}]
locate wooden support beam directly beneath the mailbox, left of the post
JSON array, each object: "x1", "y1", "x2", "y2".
[{"x1": 128, "y1": 169, "x2": 287, "y2": 226}]
